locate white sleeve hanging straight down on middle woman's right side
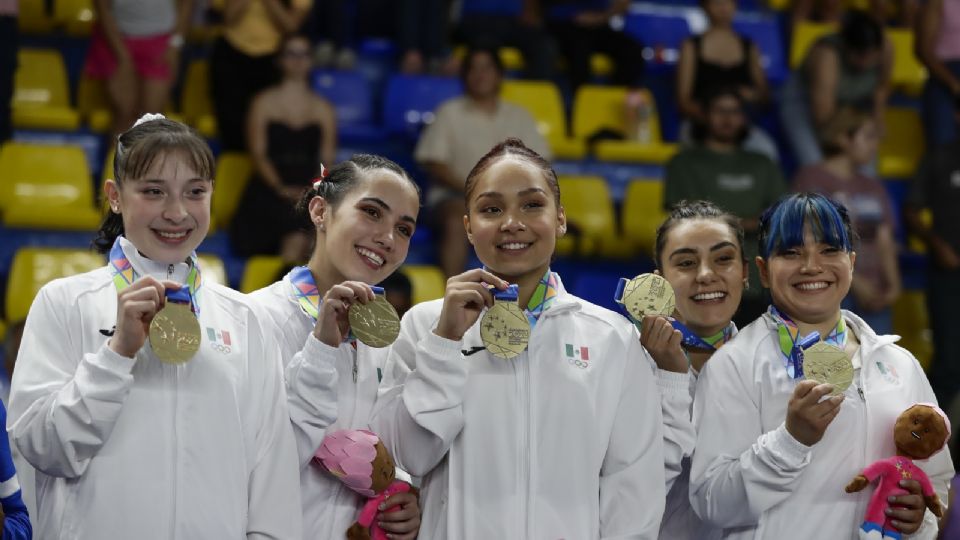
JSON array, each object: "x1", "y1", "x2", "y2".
[{"x1": 600, "y1": 339, "x2": 667, "y2": 539}]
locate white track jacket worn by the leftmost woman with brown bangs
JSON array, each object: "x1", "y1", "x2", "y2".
[{"x1": 8, "y1": 241, "x2": 301, "y2": 540}]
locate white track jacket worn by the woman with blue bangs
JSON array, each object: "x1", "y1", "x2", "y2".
[{"x1": 690, "y1": 311, "x2": 953, "y2": 540}]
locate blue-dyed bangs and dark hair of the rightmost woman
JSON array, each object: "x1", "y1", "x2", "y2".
[{"x1": 759, "y1": 193, "x2": 855, "y2": 259}]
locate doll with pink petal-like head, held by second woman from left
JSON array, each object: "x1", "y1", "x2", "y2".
[{"x1": 313, "y1": 430, "x2": 412, "y2": 540}]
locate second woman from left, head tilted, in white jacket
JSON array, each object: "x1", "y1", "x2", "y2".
[{"x1": 250, "y1": 154, "x2": 420, "y2": 540}]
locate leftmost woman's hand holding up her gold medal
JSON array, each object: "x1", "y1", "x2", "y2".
[{"x1": 107, "y1": 276, "x2": 181, "y2": 358}]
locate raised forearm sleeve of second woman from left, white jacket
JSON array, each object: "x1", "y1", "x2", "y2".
[{"x1": 284, "y1": 332, "x2": 340, "y2": 469}]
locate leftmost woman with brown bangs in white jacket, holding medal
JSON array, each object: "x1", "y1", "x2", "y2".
[{"x1": 8, "y1": 115, "x2": 300, "y2": 540}]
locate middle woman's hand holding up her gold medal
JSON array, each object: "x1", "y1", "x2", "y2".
[{"x1": 433, "y1": 268, "x2": 509, "y2": 341}]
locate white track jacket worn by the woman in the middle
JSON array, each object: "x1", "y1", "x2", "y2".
[{"x1": 371, "y1": 286, "x2": 665, "y2": 540}]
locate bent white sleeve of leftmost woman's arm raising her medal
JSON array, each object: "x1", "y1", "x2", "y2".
[{"x1": 8, "y1": 288, "x2": 136, "y2": 478}]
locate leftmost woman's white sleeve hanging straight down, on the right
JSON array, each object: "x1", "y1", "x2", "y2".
[{"x1": 246, "y1": 314, "x2": 302, "y2": 539}]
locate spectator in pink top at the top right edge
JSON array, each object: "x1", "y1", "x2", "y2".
[{"x1": 914, "y1": 0, "x2": 960, "y2": 147}]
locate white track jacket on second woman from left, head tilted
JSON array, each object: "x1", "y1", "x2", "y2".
[{"x1": 250, "y1": 277, "x2": 389, "y2": 540}]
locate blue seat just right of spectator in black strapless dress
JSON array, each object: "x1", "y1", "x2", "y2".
[{"x1": 312, "y1": 70, "x2": 382, "y2": 141}]
